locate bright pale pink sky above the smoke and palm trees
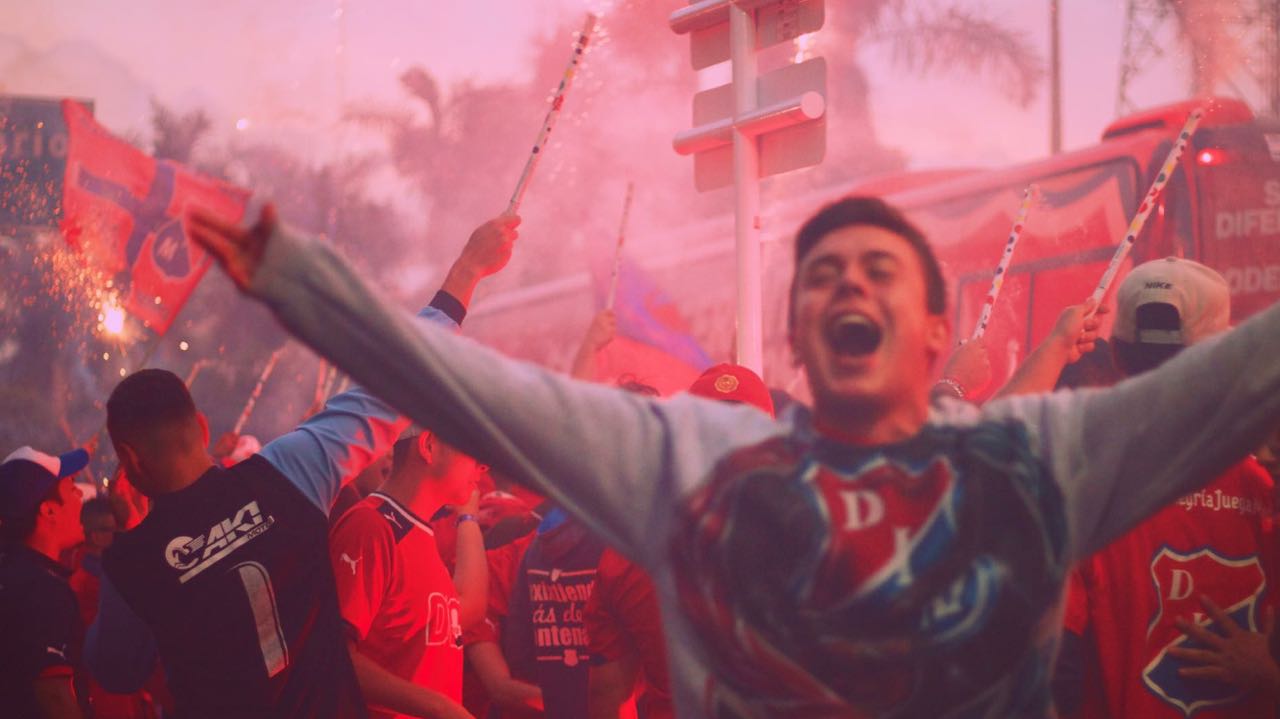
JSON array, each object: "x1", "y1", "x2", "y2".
[{"x1": 0, "y1": 0, "x2": 1218, "y2": 168}]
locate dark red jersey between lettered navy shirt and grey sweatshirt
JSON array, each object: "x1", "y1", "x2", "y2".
[{"x1": 582, "y1": 548, "x2": 676, "y2": 719}]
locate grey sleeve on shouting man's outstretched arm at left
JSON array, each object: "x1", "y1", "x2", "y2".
[{"x1": 241, "y1": 223, "x2": 783, "y2": 564}]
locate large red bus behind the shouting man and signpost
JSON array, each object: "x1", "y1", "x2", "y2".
[{"x1": 468, "y1": 99, "x2": 1280, "y2": 397}]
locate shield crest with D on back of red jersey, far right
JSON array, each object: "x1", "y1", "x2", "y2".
[{"x1": 1142, "y1": 548, "x2": 1267, "y2": 716}]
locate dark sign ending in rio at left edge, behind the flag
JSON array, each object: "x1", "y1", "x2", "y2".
[{"x1": 0, "y1": 95, "x2": 93, "y2": 228}]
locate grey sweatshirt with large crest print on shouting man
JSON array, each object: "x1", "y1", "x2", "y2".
[{"x1": 251, "y1": 221, "x2": 1280, "y2": 718}]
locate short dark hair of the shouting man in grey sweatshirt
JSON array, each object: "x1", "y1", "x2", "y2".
[{"x1": 787, "y1": 197, "x2": 947, "y2": 326}]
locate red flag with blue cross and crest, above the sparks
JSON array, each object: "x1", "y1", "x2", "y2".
[{"x1": 61, "y1": 100, "x2": 250, "y2": 334}]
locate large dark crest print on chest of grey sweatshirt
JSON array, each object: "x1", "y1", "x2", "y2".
[{"x1": 672, "y1": 421, "x2": 1066, "y2": 719}]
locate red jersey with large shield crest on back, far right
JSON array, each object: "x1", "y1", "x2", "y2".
[{"x1": 1065, "y1": 459, "x2": 1277, "y2": 719}]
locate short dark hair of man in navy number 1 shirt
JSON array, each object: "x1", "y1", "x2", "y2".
[{"x1": 106, "y1": 370, "x2": 196, "y2": 449}]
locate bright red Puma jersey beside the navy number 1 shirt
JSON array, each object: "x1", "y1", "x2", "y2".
[{"x1": 329, "y1": 491, "x2": 462, "y2": 716}]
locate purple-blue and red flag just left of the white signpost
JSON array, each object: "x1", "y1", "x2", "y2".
[{"x1": 591, "y1": 255, "x2": 712, "y2": 394}]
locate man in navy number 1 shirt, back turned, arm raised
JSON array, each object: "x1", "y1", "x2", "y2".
[{"x1": 86, "y1": 209, "x2": 518, "y2": 716}]
